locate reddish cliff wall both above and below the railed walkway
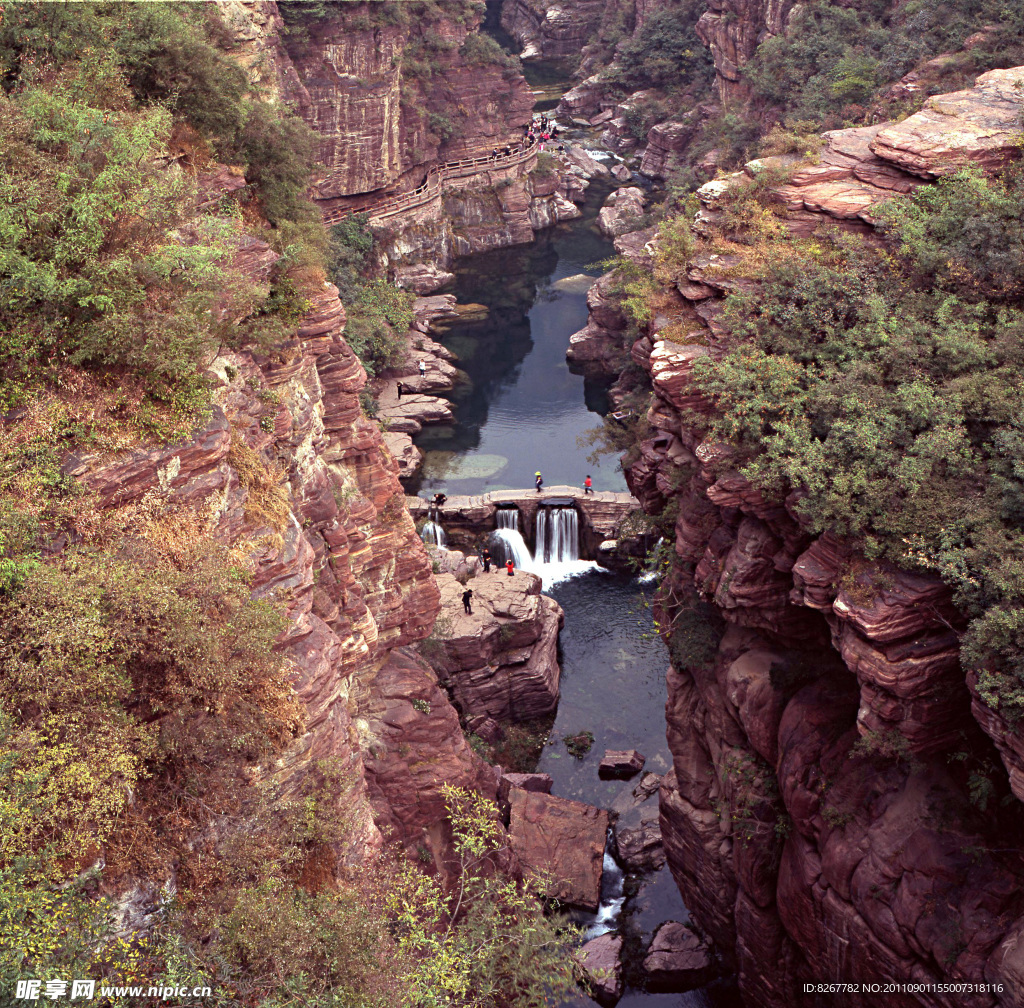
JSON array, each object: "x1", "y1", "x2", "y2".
[{"x1": 214, "y1": 0, "x2": 582, "y2": 267}]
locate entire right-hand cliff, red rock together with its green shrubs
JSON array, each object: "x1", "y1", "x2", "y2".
[{"x1": 592, "y1": 68, "x2": 1024, "y2": 1006}]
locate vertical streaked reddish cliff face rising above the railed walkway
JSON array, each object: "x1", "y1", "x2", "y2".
[{"x1": 272, "y1": 3, "x2": 532, "y2": 200}]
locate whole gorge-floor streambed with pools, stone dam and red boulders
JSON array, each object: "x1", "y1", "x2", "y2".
[{"x1": 397, "y1": 147, "x2": 740, "y2": 1008}]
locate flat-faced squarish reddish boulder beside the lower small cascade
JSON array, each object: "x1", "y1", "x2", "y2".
[{"x1": 509, "y1": 788, "x2": 608, "y2": 910}]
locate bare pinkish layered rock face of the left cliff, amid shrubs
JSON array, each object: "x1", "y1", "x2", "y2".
[{"x1": 63, "y1": 230, "x2": 496, "y2": 864}]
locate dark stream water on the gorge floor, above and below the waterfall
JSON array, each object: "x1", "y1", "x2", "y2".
[{"x1": 410, "y1": 161, "x2": 741, "y2": 1008}]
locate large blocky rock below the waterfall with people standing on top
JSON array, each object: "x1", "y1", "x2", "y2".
[{"x1": 430, "y1": 570, "x2": 564, "y2": 721}]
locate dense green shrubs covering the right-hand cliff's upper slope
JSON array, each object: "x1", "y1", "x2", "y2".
[{"x1": 693, "y1": 171, "x2": 1024, "y2": 717}]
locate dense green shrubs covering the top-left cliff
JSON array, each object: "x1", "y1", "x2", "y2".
[{"x1": 0, "y1": 4, "x2": 323, "y2": 420}]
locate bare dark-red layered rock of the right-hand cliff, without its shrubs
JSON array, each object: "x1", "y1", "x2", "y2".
[{"x1": 582, "y1": 68, "x2": 1024, "y2": 1008}]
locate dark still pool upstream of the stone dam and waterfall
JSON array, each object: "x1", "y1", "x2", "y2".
[{"x1": 408, "y1": 184, "x2": 626, "y2": 495}]
